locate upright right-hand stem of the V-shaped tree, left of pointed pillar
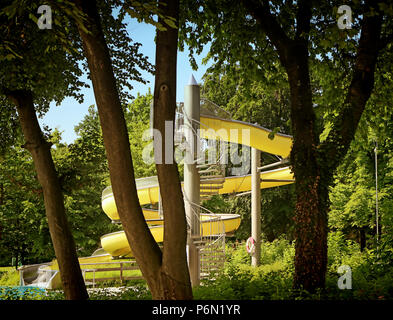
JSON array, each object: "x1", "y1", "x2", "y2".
[{"x1": 154, "y1": 0, "x2": 192, "y2": 299}]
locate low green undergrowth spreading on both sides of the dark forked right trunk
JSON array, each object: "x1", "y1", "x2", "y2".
[{"x1": 194, "y1": 233, "x2": 393, "y2": 300}]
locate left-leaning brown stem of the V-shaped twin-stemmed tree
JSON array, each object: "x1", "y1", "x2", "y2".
[{"x1": 76, "y1": 0, "x2": 191, "y2": 299}]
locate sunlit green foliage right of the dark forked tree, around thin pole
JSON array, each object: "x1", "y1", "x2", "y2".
[{"x1": 329, "y1": 90, "x2": 393, "y2": 237}]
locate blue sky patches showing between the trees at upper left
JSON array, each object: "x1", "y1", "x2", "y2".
[{"x1": 39, "y1": 19, "x2": 209, "y2": 143}]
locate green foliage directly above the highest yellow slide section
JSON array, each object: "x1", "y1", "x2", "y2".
[{"x1": 202, "y1": 66, "x2": 291, "y2": 138}]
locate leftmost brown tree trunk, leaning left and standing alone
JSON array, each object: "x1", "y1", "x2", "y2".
[{"x1": 8, "y1": 91, "x2": 89, "y2": 300}]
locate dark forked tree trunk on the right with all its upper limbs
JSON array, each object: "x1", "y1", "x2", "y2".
[{"x1": 243, "y1": 0, "x2": 383, "y2": 292}]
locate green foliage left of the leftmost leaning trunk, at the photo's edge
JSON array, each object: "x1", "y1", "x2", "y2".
[{"x1": 0, "y1": 140, "x2": 53, "y2": 264}]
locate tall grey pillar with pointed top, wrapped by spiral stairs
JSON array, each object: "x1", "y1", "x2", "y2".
[{"x1": 184, "y1": 76, "x2": 200, "y2": 286}]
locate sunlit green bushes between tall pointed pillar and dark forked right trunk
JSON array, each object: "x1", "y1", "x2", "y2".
[{"x1": 194, "y1": 239, "x2": 294, "y2": 300}]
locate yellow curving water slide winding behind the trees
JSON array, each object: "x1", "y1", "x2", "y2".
[{"x1": 101, "y1": 116, "x2": 294, "y2": 256}]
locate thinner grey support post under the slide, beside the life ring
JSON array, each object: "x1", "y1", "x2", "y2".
[{"x1": 251, "y1": 148, "x2": 261, "y2": 267}]
